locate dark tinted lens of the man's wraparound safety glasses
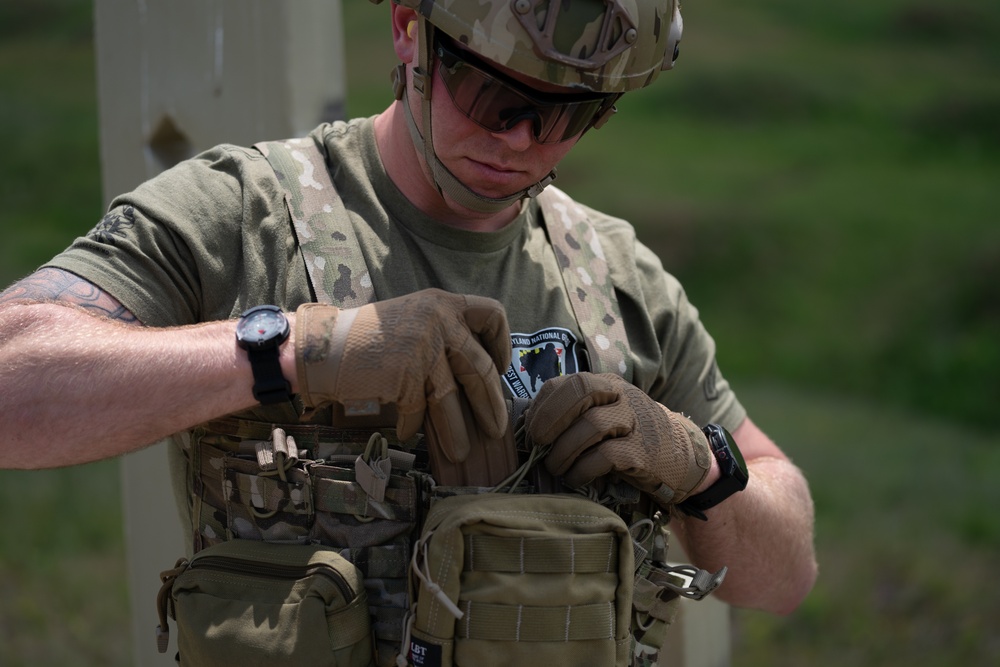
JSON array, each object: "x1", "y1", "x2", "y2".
[{"x1": 439, "y1": 54, "x2": 603, "y2": 144}]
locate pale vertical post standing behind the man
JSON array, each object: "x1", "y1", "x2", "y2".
[{"x1": 94, "y1": 0, "x2": 345, "y2": 667}]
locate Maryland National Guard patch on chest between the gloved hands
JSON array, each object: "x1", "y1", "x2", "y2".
[{"x1": 504, "y1": 327, "x2": 581, "y2": 398}]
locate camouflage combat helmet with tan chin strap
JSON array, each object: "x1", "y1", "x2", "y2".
[{"x1": 371, "y1": 0, "x2": 683, "y2": 213}]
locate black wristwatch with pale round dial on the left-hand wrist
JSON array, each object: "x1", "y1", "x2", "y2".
[{"x1": 236, "y1": 306, "x2": 292, "y2": 405}]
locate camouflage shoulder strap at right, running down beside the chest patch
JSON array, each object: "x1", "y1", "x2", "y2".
[{"x1": 538, "y1": 185, "x2": 633, "y2": 382}]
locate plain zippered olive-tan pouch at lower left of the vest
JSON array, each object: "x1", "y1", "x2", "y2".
[{"x1": 157, "y1": 540, "x2": 374, "y2": 667}]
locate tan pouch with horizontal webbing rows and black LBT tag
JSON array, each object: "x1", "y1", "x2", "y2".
[{"x1": 409, "y1": 493, "x2": 635, "y2": 667}]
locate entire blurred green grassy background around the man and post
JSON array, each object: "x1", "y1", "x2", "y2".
[{"x1": 0, "y1": 0, "x2": 1000, "y2": 666}]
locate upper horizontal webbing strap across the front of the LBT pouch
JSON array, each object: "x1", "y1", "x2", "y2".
[{"x1": 465, "y1": 533, "x2": 618, "y2": 574}]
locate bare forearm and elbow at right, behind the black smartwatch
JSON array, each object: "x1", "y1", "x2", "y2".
[{"x1": 674, "y1": 457, "x2": 816, "y2": 614}]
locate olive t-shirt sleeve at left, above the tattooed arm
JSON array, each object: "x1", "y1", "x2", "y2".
[{"x1": 47, "y1": 146, "x2": 294, "y2": 326}]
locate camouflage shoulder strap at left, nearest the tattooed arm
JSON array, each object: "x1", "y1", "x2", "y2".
[{"x1": 254, "y1": 138, "x2": 375, "y2": 308}]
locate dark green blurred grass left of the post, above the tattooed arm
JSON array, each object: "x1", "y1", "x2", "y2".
[{"x1": 0, "y1": 0, "x2": 101, "y2": 287}]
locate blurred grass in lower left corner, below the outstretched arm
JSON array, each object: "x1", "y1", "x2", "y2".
[{"x1": 0, "y1": 461, "x2": 130, "y2": 667}]
